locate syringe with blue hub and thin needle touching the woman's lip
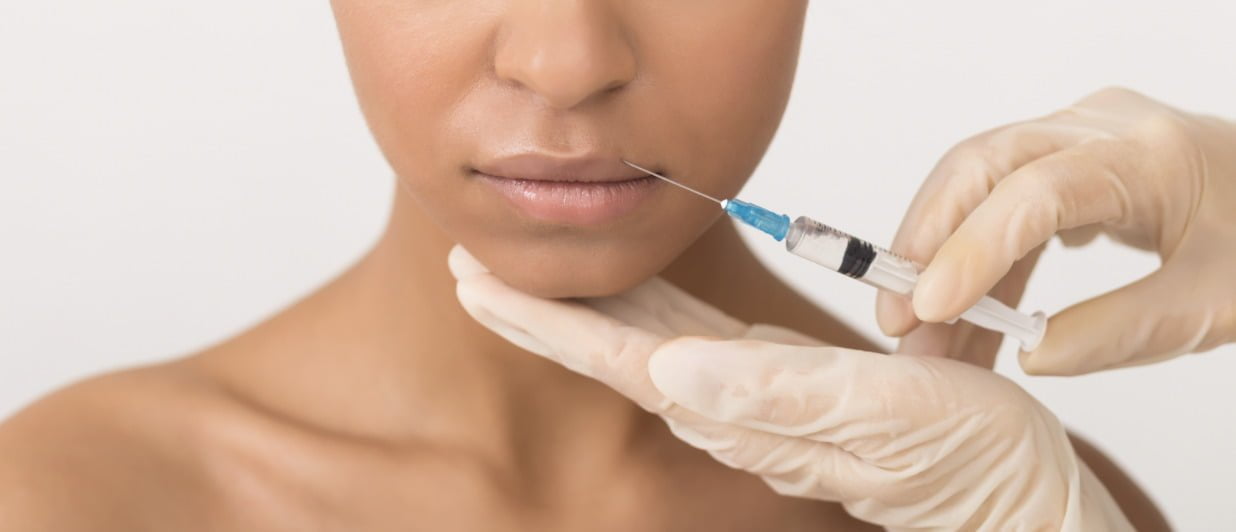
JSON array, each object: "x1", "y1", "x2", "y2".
[{"x1": 623, "y1": 161, "x2": 1047, "y2": 351}]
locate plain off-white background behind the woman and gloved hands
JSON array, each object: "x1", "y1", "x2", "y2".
[{"x1": 0, "y1": 0, "x2": 1236, "y2": 530}]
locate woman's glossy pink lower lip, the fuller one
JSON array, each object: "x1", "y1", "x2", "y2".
[{"x1": 476, "y1": 173, "x2": 658, "y2": 225}]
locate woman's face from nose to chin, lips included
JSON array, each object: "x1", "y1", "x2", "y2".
[{"x1": 332, "y1": 0, "x2": 807, "y2": 297}]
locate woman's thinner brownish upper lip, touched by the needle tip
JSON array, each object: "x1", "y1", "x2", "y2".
[{"x1": 473, "y1": 153, "x2": 648, "y2": 183}]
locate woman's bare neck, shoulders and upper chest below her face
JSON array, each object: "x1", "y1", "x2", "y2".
[{"x1": 0, "y1": 185, "x2": 1162, "y2": 531}]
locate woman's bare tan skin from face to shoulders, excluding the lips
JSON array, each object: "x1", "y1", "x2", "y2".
[{"x1": 0, "y1": 0, "x2": 1162, "y2": 532}]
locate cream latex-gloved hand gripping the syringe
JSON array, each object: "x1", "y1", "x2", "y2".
[{"x1": 878, "y1": 89, "x2": 1236, "y2": 375}]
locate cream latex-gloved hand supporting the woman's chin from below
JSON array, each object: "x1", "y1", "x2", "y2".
[{"x1": 450, "y1": 247, "x2": 1131, "y2": 531}]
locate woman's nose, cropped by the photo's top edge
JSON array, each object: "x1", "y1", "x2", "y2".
[{"x1": 493, "y1": 0, "x2": 637, "y2": 110}]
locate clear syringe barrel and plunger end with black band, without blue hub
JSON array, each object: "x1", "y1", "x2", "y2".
[{"x1": 785, "y1": 217, "x2": 1047, "y2": 351}]
